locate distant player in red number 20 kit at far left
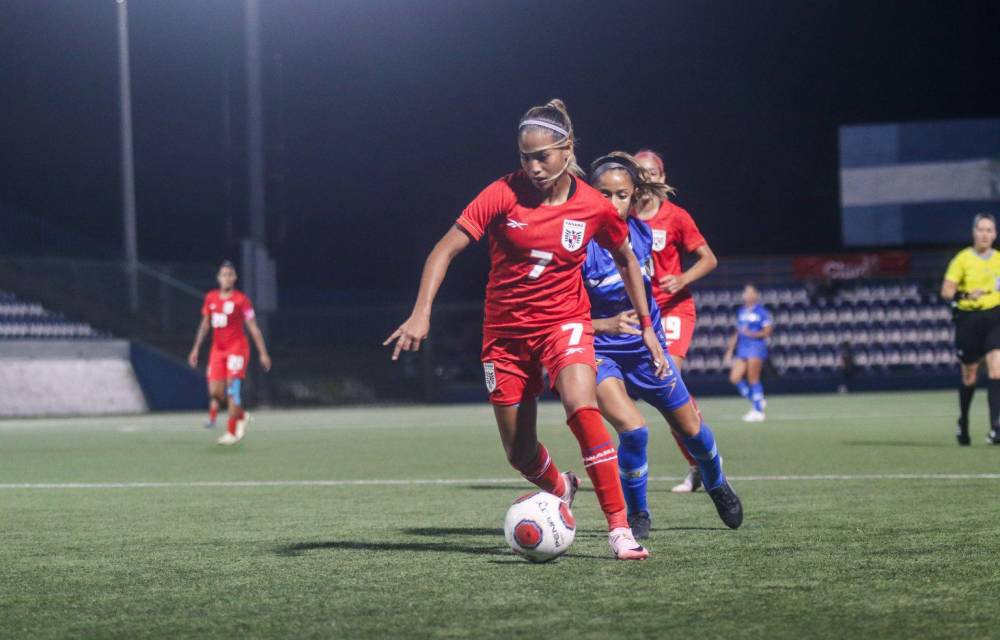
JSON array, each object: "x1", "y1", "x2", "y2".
[{"x1": 188, "y1": 260, "x2": 271, "y2": 445}]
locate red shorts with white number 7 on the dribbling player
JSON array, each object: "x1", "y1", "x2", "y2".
[{"x1": 481, "y1": 318, "x2": 597, "y2": 406}]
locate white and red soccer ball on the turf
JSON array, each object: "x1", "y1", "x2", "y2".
[{"x1": 503, "y1": 491, "x2": 576, "y2": 562}]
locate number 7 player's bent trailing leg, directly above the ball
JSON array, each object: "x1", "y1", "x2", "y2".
[{"x1": 493, "y1": 398, "x2": 580, "y2": 506}]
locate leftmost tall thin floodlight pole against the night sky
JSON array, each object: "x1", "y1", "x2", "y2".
[{"x1": 116, "y1": 0, "x2": 139, "y2": 313}]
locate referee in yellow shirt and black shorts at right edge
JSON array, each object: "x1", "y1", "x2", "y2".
[{"x1": 941, "y1": 213, "x2": 1000, "y2": 445}]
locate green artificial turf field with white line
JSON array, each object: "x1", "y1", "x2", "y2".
[{"x1": 0, "y1": 393, "x2": 1000, "y2": 639}]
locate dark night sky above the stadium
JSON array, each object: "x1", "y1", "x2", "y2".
[{"x1": 0, "y1": 0, "x2": 1000, "y2": 297}]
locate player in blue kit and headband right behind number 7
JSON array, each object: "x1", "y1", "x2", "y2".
[{"x1": 583, "y1": 151, "x2": 743, "y2": 538}]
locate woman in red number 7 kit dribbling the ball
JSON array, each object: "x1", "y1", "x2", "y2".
[{"x1": 384, "y1": 100, "x2": 667, "y2": 560}]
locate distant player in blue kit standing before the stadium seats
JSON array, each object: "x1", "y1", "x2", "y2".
[{"x1": 724, "y1": 284, "x2": 774, "y2": 422}]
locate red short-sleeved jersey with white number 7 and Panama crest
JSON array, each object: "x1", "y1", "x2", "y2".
[{"x1": 456, "y1": 171, "x2": 628, "y2": 338}]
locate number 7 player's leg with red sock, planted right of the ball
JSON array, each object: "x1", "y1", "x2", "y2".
[{"x1": 555, "y1": 364, "x2": 649, "y2": 560}]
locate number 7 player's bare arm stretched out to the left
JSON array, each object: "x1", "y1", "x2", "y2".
[{"x1": 382, "y1": 226, "x2": 471, "y2": 360}]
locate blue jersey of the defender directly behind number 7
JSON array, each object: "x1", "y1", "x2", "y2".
[{"x1": 583, "y1": 217, "x2": 667, "y2": 355}]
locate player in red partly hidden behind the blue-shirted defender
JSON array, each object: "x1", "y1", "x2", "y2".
[{"x1": 635, "y1": 149, "x2": 719, "y2": 493}]
